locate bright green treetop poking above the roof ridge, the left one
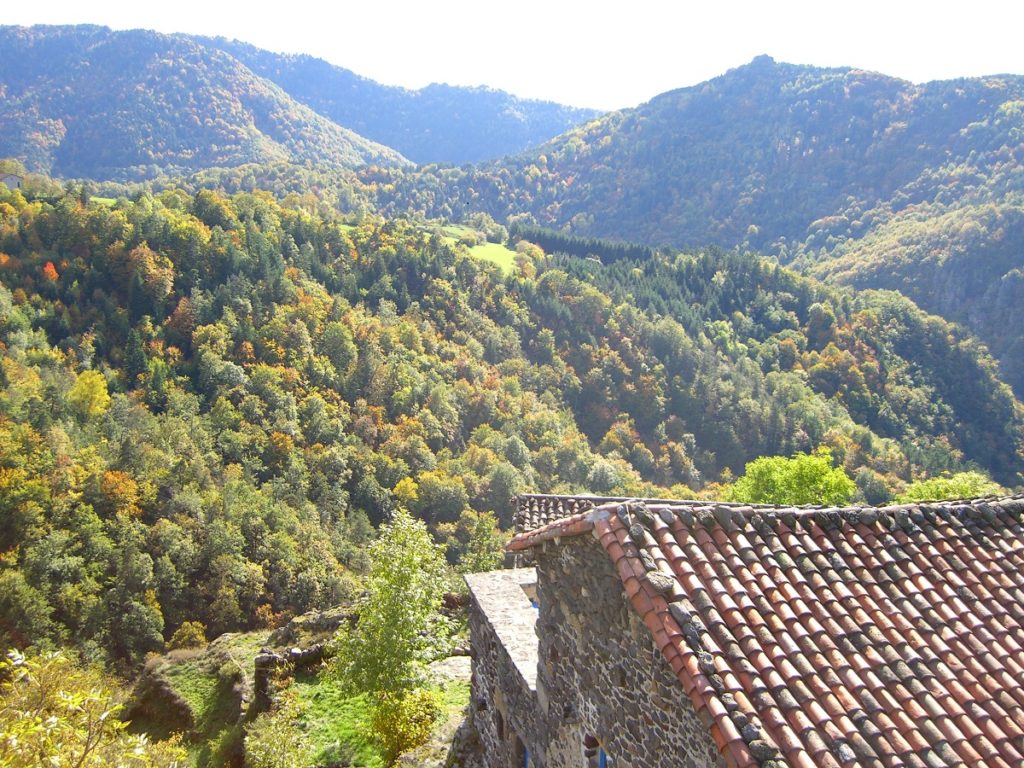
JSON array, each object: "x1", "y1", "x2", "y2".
[{"x1": 731, "y1": 449, "x2": 857, "y2": 506}]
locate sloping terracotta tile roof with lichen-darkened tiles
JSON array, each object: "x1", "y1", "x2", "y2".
[{"x1": 509, "y1": 497, "x2": 1024, "y2": 768}]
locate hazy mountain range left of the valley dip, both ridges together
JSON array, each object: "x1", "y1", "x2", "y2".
[{"x1": 0, "y1": 26, "x2": 598, "y2": 180}]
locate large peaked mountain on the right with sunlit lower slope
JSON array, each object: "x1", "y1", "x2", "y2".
[{"x1": 374, "y1": 56, "x2": 1024, "y2": 393}]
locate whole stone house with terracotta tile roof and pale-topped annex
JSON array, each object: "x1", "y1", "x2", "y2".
[{"x1": 467, "y1": 497, "x2": 1024, "y2": 768}]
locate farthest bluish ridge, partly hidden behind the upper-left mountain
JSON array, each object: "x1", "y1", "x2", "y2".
[{"x1": 194, "y1": 38, "x2": 601, "y2": 165}]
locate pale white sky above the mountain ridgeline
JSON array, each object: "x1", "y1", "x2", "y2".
[{"x1": 8, "y1": 0, "x2": 1024, "y2": 109}]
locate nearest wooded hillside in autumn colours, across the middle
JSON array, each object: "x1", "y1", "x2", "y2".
[{"x1": 0, "y1": 185, "x2": 1024, "y2": 666}]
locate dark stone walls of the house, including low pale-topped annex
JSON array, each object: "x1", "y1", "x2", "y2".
[{"x1": 466, "y1": 536, "x2": 725, "y2": 768}]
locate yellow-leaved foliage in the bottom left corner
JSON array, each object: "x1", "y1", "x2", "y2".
[{"x1": 0, "y1": 651, "x2": 185, "y2": 768}]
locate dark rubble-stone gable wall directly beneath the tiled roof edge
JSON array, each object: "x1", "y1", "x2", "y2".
[{"x1": 532, "y1": 536, "x2": 724, "y2": 768}]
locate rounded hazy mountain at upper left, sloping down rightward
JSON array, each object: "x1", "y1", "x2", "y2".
[{"x1": 0, "y1": 27, "x2": 408, "y2": 179}]
